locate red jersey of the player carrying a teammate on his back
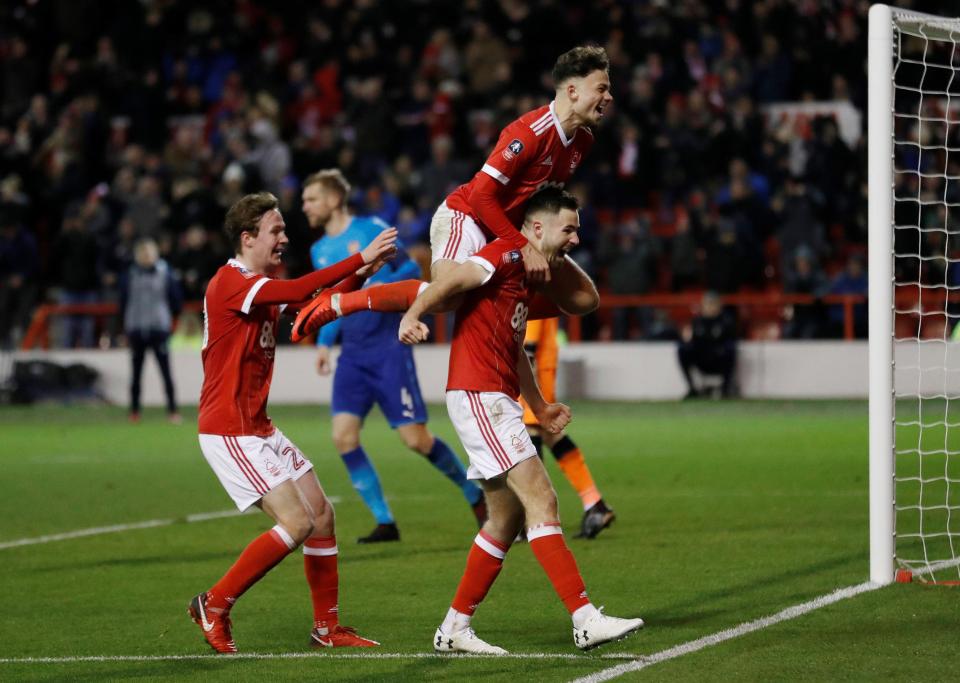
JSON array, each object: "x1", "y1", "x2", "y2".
[{"x1": 447, "y1": 240, "x2": 530, "y2": 398}]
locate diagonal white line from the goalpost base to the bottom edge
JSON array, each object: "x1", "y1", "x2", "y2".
[{"x1": 572, "y1": 582, "x2": 883, "y2": 683}]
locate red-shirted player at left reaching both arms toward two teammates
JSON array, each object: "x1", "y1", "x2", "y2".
[{"x1": 188, "y1": 192, "x2": 397, "y2": 653}]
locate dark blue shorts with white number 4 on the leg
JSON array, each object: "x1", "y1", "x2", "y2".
[{"x1": 331, "y1": 346, "x2": 427, "y2": 429}]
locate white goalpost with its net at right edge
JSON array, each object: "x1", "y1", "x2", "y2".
[{"x1": 868, "y1": 5, "x2": 960, "y2": 584}]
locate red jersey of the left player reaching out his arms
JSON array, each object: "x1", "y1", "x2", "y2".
[{"x1": 199, "y1": 259, "x2": 281, "y2": 436}]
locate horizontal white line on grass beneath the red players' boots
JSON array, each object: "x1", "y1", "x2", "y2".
[{"x1": 0, "y1": 652, "x2": 639, "y2": 664}]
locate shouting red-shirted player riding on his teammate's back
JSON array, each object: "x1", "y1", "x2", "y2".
[{"x1": 293, "y1": 46, "x2": 613, "y2": 341}]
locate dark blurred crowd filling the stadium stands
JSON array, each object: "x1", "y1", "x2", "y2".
[{"x1": 0, "y1": 0, "x2": 948, "y2": 345}]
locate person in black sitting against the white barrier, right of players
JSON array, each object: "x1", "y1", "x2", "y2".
[{"x1": 677, "y1": 291, "x2": 737, "y2": 398}]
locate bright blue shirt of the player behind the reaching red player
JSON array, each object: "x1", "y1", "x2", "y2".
[{"x1": 310, "y1": 216, "x2": 420, "y2": 354}]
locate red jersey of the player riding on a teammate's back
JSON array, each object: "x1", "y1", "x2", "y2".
[{"x1": 447, "y1": 102, "x2": 593, "y2": 238}]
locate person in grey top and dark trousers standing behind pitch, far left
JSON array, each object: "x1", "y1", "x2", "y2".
[{"x1": 120, "y1": 238, "x2": 183, "y2": 423}]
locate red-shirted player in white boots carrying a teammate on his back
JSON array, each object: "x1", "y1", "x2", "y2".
[{"x1": 399, "y1": 188, "x2": 643, "y2": 654}]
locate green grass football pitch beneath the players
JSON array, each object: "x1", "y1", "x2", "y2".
[{"x1": 0, "y1": 401, "x2": 960, "y2": 683}]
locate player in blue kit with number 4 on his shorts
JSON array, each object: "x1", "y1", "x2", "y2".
[{"x1": 302, "y1": 169, "x2": 486, "y2": 543}]
